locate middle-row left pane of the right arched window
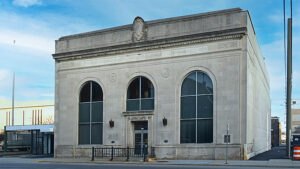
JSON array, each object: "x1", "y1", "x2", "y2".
[{"x1": 181, "y1": 96, "x2": 196, "y2": 119}]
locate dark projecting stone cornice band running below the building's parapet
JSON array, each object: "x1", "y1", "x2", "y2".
[{"x1": 53, "y1": 28, "x2": 247, "y2": 61}]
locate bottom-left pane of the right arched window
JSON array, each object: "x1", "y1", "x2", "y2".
[{"x1": 180, "y1": 120, "x2": 196, "y2": 143}]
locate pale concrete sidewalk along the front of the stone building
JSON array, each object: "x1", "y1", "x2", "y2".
[{"x1": 35, "y1": 158, "x2": 300, "y2": 168}]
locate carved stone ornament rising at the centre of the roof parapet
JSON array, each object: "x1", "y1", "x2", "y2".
[{"x1": 132, "y1": 16, "x2": 146, "y2": 42}]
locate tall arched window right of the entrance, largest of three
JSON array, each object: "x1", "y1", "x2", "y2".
[{"x1": 180, "y1": 71, "x2": 213, "y2": 143}]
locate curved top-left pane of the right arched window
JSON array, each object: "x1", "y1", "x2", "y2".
[{"x1": 181, "y1": 72, "x2": 196, "y2": 96}]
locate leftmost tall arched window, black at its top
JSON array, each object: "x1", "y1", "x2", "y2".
[{"x1": 79, "y1": 81, "x2": 103, "y2": 144}]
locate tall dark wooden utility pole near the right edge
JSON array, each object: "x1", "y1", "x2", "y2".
[{"x1": 286, "y1": 18, "x2": 292, "y2": 158}]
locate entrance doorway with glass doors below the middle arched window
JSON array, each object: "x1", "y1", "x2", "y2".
[{"x1": 133, "y1": 121, "x2": 148, "y2": 155}]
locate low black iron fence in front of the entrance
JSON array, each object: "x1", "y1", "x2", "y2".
[{"x1": 92, "y1": 147, "x2": 155, "y2": 161}]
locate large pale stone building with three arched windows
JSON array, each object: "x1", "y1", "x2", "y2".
[{"x1": 53, "y1": 8, "x2": 271, "y2": 159}]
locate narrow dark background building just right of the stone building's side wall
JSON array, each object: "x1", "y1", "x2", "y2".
[{"x1": 271, "y1": 117, "x2": 281, "y2": 147}]
